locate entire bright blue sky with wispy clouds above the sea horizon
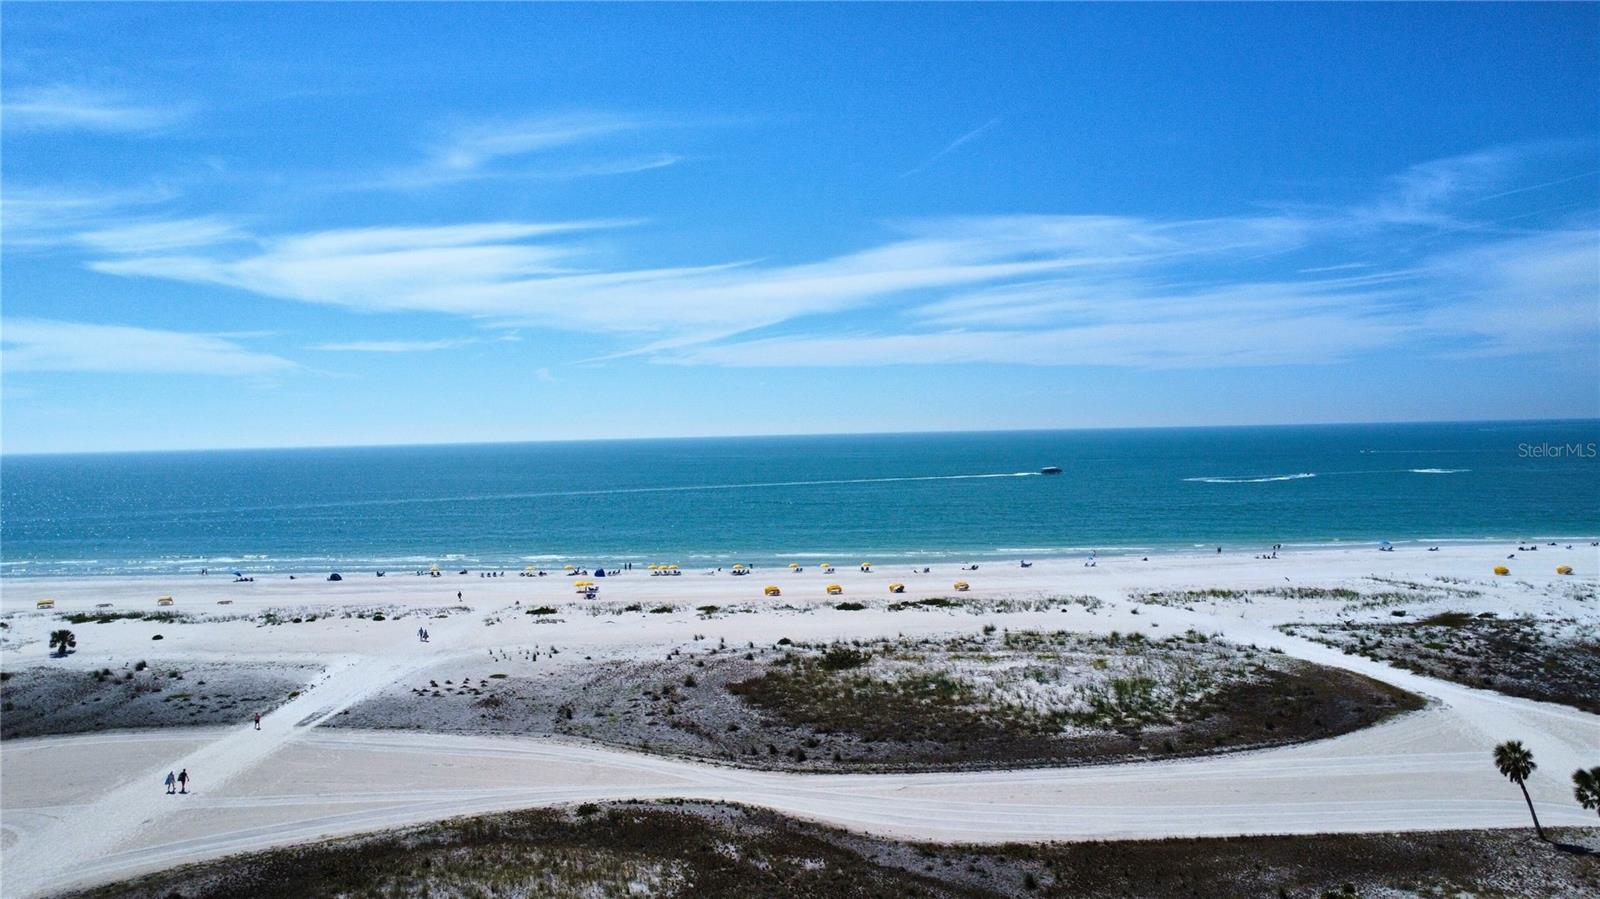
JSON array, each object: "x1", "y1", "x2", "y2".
[{"x1": 0, "y1": 3, "x2": 1600, "y2": 453}]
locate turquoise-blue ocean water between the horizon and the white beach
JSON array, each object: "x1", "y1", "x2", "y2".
[{"x1": 0, "y1": 421, "x2": 1600, "y2": 576}]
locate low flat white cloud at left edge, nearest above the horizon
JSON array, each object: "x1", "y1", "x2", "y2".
[{"x1": 0, "y1": 318, "x2": 296, "y2": 376}]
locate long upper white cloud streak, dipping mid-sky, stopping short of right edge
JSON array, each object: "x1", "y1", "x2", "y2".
[{"x1": 81, "y1": 216, "x2": 1301, "y2": 343}]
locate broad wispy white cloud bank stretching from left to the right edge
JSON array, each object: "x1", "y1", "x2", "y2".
[{"x1": 62, "y1": 144, "x2": 1600, "y2": 368}]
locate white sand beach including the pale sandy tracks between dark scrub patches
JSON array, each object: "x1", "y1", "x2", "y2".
[{"x1": 0, "y1": 539, "x2": 1600, "y2": 897}]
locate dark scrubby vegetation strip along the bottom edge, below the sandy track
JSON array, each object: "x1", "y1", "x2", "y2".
[{"x1": 74, "y1": 801, "x2": 1600, "y2": 899}]
